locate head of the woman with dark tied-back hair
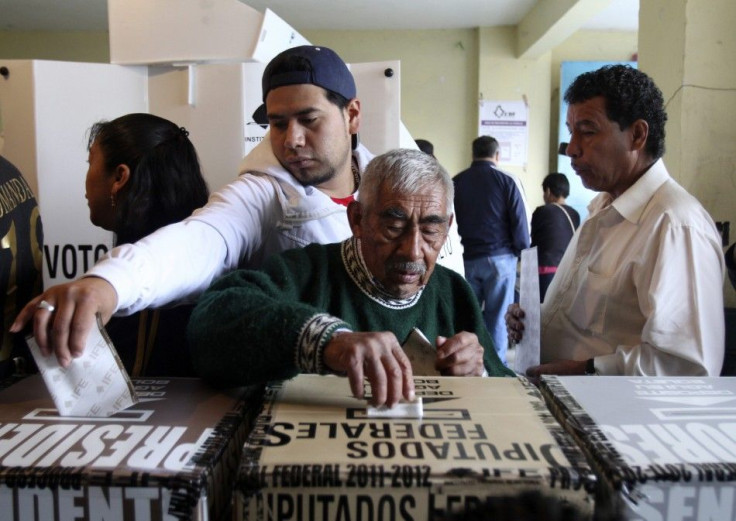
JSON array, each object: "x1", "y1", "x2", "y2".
[{"x1": 86, "y1": 114, "x2": 209, "y2": 245}]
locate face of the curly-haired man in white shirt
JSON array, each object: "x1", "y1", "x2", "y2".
[{"x1": 565, "y1": 96, "x2": 639, "y2": 197}]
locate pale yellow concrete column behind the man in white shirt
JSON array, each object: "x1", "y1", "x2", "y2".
[{"x1": 639, "y1": 0, "x2": 736, "y2": 307}]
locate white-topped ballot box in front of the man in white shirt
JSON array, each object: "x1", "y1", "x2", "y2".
[{"x1": 541, "y1": 376, "x2": 736, "y2": 521}]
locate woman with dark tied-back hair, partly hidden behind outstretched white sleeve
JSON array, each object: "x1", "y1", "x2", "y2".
[{"x1": 85, "y1": 114, "x2": 209, "y2": 376}]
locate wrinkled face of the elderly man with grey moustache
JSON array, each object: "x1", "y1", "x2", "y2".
[{"x1": 348, "y1": 182, "x2": 452, "y2": 298}]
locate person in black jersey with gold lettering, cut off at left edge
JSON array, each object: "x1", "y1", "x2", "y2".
[{"x1": 0, "y1": 156, "x2": 43, "y2": 388}]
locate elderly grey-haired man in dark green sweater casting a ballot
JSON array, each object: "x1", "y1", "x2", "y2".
[{"x1": 189, "y1": 149, "x2": 514, "y2": 406}]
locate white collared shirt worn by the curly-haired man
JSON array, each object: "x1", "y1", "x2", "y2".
[{"x1": 541, "y1": 159, "x2": 725, "y2": 376}]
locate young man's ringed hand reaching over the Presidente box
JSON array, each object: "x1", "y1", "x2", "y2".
[{"x1": 10, "y1": 277, "x2": 117, "y2": 367}]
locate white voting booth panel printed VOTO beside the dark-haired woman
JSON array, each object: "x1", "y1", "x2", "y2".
[{"x1": 0, "y1": 60, "x2": 148, "y2": 287}]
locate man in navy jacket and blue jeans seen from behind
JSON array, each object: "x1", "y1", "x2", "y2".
[{"x1": 453, "y1": 136, "x2": 529, "y2": 363}]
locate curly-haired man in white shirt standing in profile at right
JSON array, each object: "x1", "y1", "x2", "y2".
[{"x1": 506, "y1": 65, "x2": 725, "y2": 377}]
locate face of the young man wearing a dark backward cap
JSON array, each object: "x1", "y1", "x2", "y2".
[{"x1": 266, "y1": 84, "x2": 360, "y2": 188}]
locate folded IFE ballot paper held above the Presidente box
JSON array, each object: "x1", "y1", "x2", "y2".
[{"x1": 27, "y1": 316, "x2": 138, "y2": 417}]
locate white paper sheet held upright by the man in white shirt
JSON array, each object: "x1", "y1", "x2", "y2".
[{"x1": 514, "y1": 246, "x2": 541, "y2": 374}]
